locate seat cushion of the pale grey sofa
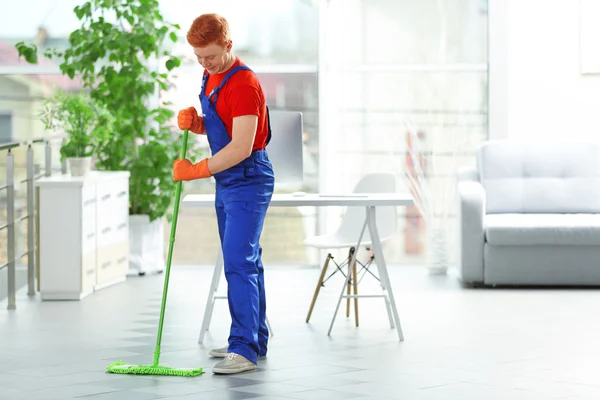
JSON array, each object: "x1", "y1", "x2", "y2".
[{"x1": 484, "y1": 214, "x2": 600, "y2": 246}]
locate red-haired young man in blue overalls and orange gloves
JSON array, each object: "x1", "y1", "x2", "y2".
[{"x1": 173, "y1": 14, "x2": 275, "y2": 374}]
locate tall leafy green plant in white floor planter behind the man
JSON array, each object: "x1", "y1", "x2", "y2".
[{"x1": 16, "y1": 0, "x2": 199, "y2": 274}]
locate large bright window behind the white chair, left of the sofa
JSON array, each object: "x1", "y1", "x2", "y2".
[{"x1": 319, "y1": 0, "x2": 488, "y2": 263}]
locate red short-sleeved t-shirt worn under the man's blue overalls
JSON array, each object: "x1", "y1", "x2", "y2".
[{"x1": 204, "y1": 58, "x2": 269, "y2": 150}]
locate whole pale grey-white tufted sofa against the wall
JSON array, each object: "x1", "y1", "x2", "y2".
[{"x1": 457, "y1": 141, "x2": 600, "y2": 286}]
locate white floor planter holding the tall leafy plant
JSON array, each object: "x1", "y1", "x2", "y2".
[{"x1": 128, "y1": 215, "x2": 165, "y2": 275}]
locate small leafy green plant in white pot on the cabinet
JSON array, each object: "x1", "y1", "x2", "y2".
[{"x1": 41, "y1": 91, "x2": 114, "y2": 177}]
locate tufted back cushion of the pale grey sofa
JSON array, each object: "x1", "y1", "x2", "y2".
[{"x1": 477, "y1": 141, "x2": 600, "y2": 214}]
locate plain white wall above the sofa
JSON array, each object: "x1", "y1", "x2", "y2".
[{"x1": 490, "y1": 0, "x2": 600, "y2": 141}]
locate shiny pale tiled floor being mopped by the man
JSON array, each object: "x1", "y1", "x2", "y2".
[{"x1": 0, "y1": 267, "x2": 600, "y2": 400}]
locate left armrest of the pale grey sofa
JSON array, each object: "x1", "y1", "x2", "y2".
[{"x1": 457, "y1": 167, "x2": 485, "y2": 283}]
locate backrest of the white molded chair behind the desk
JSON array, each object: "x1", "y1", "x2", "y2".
[{"x1": 338, "y1": 173, "x2": 398, "y2": 240}]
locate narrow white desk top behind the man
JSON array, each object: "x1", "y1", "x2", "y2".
[{"x1": 181, "y1": 193, "x2": 413, "y2": 207}]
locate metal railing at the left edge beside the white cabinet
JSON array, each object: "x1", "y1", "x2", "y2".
[{"x1": 0, "y1": 136, "x2": 66, "y2": 310}]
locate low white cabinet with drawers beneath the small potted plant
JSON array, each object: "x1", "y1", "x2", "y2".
[{"x1": 36, "y1": 171, "x2": 129, "y2": 300}]
